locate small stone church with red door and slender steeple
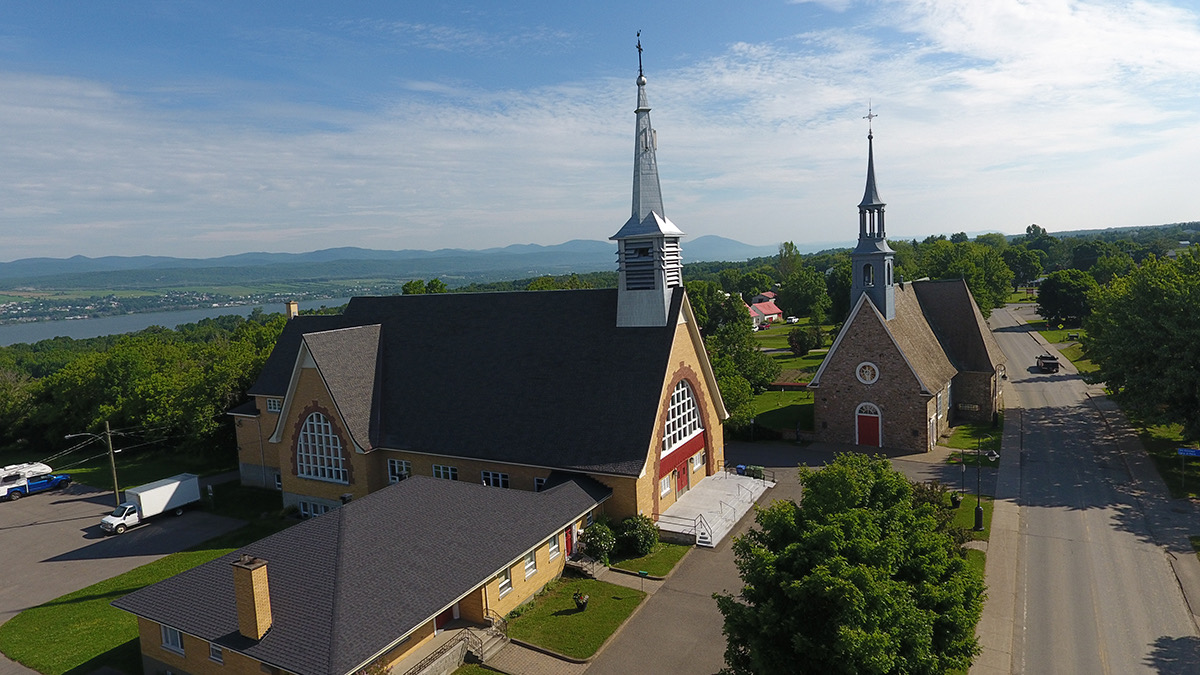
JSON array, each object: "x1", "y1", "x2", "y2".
[{"x1": 809, "y1": 126, "x2": 1004, "y2": 452}]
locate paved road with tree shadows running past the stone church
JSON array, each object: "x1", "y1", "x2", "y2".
[{"x1": 991, "y1": 309, "x2": 1200, "y2": 675}]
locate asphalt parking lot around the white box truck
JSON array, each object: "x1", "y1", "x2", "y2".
[{"x1": 0, "y1": 484, "x2": 241, "y2": 675}]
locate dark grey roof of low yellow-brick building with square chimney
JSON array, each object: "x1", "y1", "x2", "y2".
[{"x1": 113, "y1": 476, "x2": 611, "y2": 675}]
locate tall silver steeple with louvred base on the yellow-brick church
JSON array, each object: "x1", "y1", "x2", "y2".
[{"x1": 610, "y1": 31, "x2": 683, "y2": 327}]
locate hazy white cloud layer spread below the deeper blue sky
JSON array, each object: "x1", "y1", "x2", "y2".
[{"x1": 0, "y1": 0, "x2": 1200, "y2": 259}]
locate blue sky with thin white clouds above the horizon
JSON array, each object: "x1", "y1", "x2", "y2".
[{"x1": 0, "y1": 0, "x2": 1200, "y2": 261}]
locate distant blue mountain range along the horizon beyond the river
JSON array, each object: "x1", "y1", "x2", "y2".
[{"x1": 0, "y1": 235, "x2": 779, "y2": 288}]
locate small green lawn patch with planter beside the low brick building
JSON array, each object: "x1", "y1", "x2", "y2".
[{"x1": 509, "y1": 578, "x2": 646, "y2": 658}]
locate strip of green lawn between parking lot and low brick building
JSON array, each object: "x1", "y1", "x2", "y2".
[{"x1": 0, "y1": 484, "x2": 295, "y2": 675}]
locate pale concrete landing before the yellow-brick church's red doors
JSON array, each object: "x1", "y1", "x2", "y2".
[{"x1": 658, "y1": 471, "x2": 775, "y2": 548}]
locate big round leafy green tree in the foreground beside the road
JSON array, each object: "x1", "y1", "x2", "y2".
[{"x1": 715, "y1": 454, "x2": 984, "y2": 675}]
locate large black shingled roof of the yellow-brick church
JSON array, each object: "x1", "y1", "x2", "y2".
[{"x1": 251, "y1": 288, "x2": 691, "y2": 476}]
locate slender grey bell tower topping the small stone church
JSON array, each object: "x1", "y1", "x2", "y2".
[{"x1": 850, "y1": 109, "x2": 896, "y2": 319}]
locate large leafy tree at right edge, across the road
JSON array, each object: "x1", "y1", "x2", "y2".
[{"x1": 1084, "y1": 246, "x2": 1200, "y2": 440}]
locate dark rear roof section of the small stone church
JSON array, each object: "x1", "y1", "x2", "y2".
[{"x1": 912, "y1": 279, "x2": 1004, "y2": 372}]
